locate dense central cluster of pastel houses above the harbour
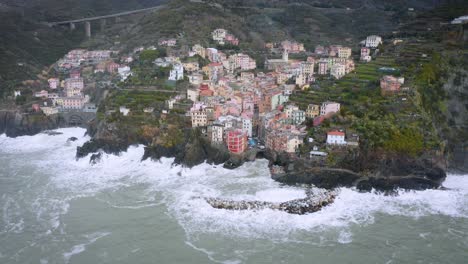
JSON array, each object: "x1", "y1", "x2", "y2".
[{"x1": 155, "y1": 36, "x2": 351, "y2": 154}]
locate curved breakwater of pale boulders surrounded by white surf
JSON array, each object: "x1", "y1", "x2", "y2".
[{"x1": 205, "y1": 189, "x2": 337, "y2": 215}]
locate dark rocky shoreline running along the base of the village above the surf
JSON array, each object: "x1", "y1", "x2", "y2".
[{"x1": 0, "y1": 111, "x2": 460, "y2": 191}]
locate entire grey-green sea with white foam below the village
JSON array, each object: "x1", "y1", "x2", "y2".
[{"x1": 0, "y1": 128, "x2": 468, "y2": 264}]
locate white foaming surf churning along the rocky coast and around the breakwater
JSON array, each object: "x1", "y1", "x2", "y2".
[{"x1": 0, "y1": 128, "x2": 468, "y2": 263}]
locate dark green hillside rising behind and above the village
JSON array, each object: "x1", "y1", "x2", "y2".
[{"x1": 0, "y1": 0, "x2": 463, "y2": 97}]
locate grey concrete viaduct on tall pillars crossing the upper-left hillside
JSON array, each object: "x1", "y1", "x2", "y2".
[{"x1": 46, "y1": 5, "x2": 163, "y2": 38}]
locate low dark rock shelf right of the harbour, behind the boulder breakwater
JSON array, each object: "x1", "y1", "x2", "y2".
[{"x1": 272, "y1": 156, "x2": 446, "y2": 191}]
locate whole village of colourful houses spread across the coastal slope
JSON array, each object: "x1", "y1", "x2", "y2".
[{"x1": 15, "y1": 28, "x2": 416, "y2": 163}]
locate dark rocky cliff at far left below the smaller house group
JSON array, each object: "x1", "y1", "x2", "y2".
[{"x1": 0, "y1": 111, "x2": 66, "y2": 137}]
